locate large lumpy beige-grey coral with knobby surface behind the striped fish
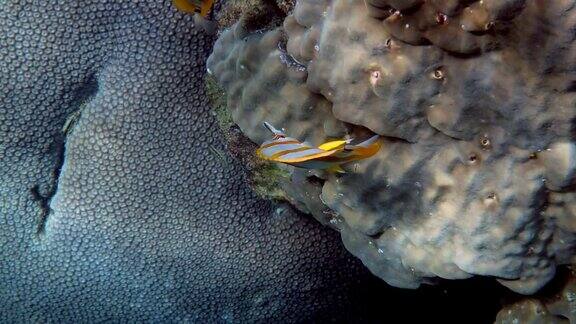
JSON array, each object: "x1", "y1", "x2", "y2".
[{"x1": 208, "y1": 0, "x2": 576, "y2": 294}]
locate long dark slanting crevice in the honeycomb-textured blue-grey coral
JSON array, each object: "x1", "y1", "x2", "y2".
[{"x1": 30, "y1": 74, "x2": 98, "y2": 237}]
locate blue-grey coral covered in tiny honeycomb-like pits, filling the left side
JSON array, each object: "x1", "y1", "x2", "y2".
[{"x1": 0, "y1": 0, "x2": 410, "y2": 323}]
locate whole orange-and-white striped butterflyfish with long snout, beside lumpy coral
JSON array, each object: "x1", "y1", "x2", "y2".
[{"x1": 256, "y1": 122, "x2": 382, "y2": 172}]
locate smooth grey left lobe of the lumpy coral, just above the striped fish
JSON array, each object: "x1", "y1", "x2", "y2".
[{"x1": 207, "y1": 24, "x2": 345, "y2": 146}]
